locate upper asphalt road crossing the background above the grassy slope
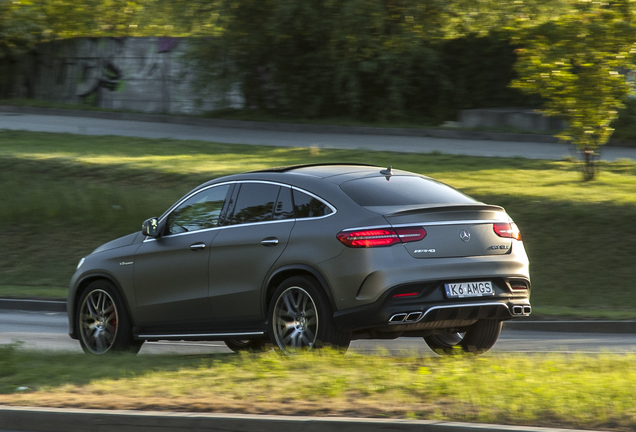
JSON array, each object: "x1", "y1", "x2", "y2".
[{"x1": 0, "y1": 112, "x2": 636, "y2": 160}]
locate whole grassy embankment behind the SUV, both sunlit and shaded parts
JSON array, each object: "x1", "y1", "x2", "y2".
[{"x1": 0, "y1": 131, "x2": 636, "y2": 319}]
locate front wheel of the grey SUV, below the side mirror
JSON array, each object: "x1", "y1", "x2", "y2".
[{"x1": 75, "y1": 280, "x2": 143, "y2": 355}]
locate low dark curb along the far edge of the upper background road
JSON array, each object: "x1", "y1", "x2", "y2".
[{"x1": 0, "y1": 106, "x2": 559, "y2": 144}]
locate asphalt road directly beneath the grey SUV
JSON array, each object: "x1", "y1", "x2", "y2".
[{"x1": 0, "y1": 310, "x2": 636, "y2": 355}]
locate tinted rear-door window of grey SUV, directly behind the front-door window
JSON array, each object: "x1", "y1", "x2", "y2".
[{"x1": 228, "y1": 183, "x2": 280, "y2": 225}]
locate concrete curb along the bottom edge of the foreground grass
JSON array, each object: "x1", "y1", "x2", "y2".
[{"x1": 0, "y1": 406, "x2": 590, "y2": 432}]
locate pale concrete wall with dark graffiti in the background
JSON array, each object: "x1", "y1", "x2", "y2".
[{"x1": 12, "y1": 37, "x2": 242, "y2": 114}]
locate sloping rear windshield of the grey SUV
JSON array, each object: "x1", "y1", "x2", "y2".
[{"x1": 340, "y1": 176, "x2": 477, "y2": 207}]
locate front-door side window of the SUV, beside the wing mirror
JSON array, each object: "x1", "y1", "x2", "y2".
[{"x1": 166, "y1": 185, "x2": 230, "y2": 234}]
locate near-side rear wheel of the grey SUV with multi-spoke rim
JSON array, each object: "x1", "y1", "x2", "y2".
[{"x1": 268, "y1": 276, "x2": 351, "y2": 355}]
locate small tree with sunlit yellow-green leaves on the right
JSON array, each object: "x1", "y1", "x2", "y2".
[{"x1": 512, "y1": 0, "x2": 636, "y2": 180}]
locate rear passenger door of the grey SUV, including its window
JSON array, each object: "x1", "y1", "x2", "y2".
[{"x1": 209, "y1": 182, "x2": 294, "y2": 327}]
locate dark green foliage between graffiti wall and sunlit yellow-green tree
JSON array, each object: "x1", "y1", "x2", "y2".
[{"x1": 184, "y1": 0, "x2": 561, "y2": 120}]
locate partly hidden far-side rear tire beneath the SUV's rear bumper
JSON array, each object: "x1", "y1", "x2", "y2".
[{"x1": 424, "y1": 320, "x2": 501, "y2": 355}]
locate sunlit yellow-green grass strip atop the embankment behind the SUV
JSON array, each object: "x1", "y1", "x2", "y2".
[{"x1": 6, "y1": 131, "x2": 636, "y2": 204}]
